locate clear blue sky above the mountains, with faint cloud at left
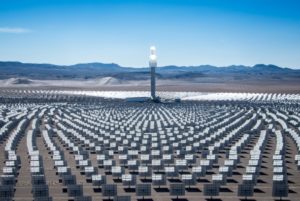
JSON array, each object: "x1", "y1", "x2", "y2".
[{"x1": 0, "y1": 0, "x2": 300, "y2": 68}]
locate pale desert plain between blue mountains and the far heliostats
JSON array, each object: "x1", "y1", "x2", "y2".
[{"x1": 0, "y1": 78, "x2": 300, "y2": 93}]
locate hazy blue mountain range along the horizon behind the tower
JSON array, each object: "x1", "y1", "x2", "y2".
[{"x1": 0, "y1": 62, "x2": 300, "y2": 80}]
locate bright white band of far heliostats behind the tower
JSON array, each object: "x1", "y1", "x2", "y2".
[{"x1": 0, "y1": 89, "x2": 300, "y2": 102}]
